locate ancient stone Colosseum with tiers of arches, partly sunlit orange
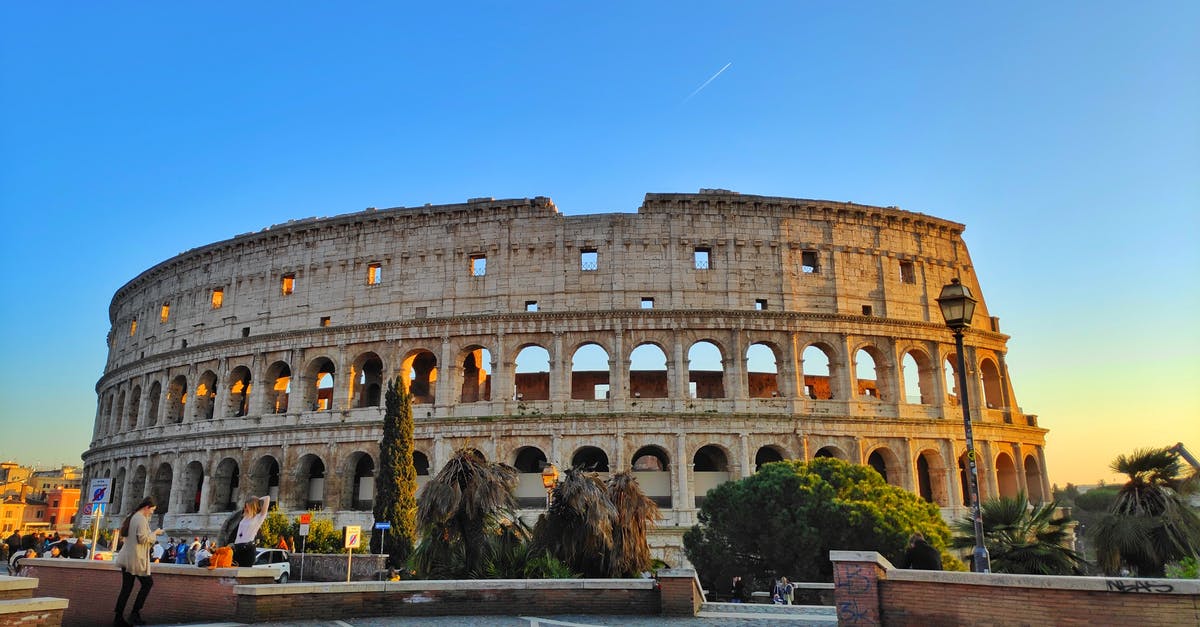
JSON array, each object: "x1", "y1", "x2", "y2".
[{"x1": 84, "y1": 190, "x2": 1050, "y2": 563}]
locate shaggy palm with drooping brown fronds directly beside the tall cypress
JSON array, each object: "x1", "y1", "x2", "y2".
[{"x1": 414, "y1": 448, "x2": 518, "y2": 577}]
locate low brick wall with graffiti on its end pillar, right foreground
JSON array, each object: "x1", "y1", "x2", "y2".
[{"x1": 830, "y1": 551, "x2": 1200, "y2": 627}]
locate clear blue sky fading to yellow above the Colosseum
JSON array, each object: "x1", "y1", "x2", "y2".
[{"x1": 0, "y1": 1, "x2": 1200, "y2": 483}]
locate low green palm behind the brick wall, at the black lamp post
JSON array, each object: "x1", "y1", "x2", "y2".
[{"x1": 952, "y1": 492, "x2": 1085, "y2": 575}]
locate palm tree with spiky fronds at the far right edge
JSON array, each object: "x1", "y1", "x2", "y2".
[{"x1": 1096, "y1": 448, "x2": 1200, "y2": 577}]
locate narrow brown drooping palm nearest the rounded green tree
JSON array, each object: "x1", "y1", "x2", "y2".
[{"x1": 607, "y1": 471, "x2": 659, "y2": 577}]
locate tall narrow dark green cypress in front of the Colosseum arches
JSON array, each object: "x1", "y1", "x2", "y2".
[{"x1": 371, "y1": 377, "x2": 416, "y2": 568}]
